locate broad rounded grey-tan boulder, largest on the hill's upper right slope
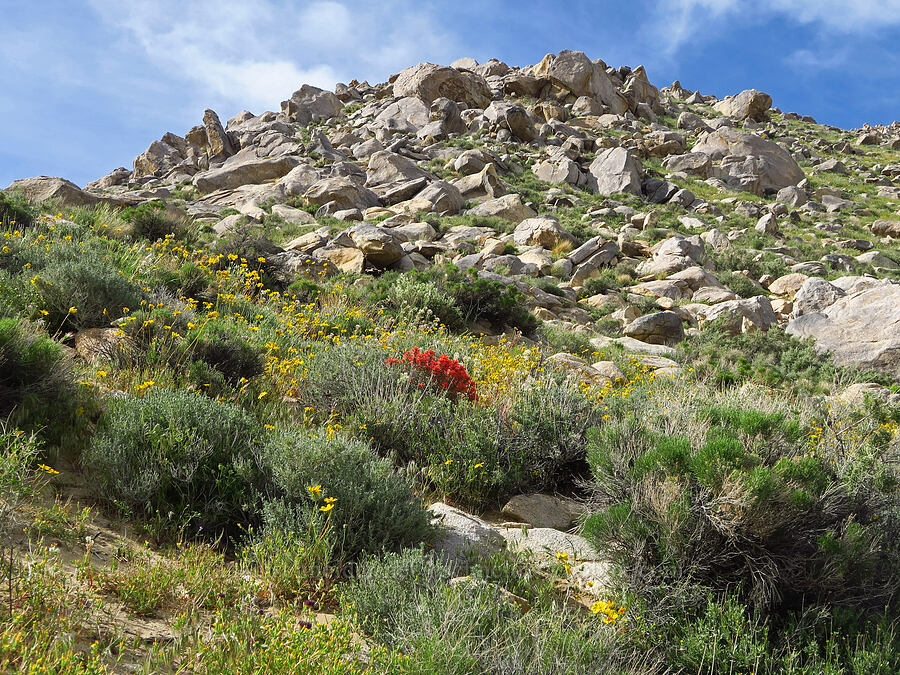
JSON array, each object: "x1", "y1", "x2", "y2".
[{"x1": 693, "y1": 127, "x2": 804, "y2": 194}]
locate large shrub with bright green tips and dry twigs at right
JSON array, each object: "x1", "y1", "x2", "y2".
[{"x1": 585, "y1": 399, "x2": 900, "y2": 608}]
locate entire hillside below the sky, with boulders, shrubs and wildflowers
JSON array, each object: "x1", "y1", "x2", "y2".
[{"x1": 0, "y1": 51, "x2": 900, "y2": 673}]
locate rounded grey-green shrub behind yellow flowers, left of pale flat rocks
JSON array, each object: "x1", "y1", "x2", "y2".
[{"x1": 263, "y1": 429, "x2": 432, "y2": 559}]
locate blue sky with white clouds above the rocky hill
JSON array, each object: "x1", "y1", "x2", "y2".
[{"x1": 0, "y1": 0, "x2": 900, "y2": 187}]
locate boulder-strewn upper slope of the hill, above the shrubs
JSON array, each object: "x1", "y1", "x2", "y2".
[{"x1": 8, "y1": 51, "x2": 900, "y2": 377}]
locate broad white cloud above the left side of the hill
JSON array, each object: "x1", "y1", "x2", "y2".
[{"x1": 89, "y1": 0, "x2": 455, "y2": 111}]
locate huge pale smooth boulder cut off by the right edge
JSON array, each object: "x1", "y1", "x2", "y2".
[{"x1": 786, "y1": 283, "x2": 900, "y2": 381}]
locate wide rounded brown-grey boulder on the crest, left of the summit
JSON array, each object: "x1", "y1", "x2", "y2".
[{"x1": 394, "y1": 63, "x2": 491, "y2": 108}]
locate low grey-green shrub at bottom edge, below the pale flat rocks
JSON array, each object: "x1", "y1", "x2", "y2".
[{"x1": 341, "y1": 550, "x2": 636, "y2": 674}]
